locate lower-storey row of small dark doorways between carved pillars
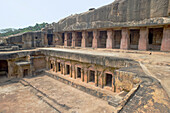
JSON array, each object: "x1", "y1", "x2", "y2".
[{"x1": 47, "y1": 58, "x2": 116, "y2": 91}]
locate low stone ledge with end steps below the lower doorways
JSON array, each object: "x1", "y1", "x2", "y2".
[{"x1": 44, "y1": 70, "x2": 139, "y2": 111}]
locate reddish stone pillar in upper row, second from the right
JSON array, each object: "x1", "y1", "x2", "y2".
[{"x1": 138, "y1": 28, "x2": 149, "y2": 51}]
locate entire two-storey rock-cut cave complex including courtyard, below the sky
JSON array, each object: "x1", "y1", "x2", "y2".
[{"x1": 0, "y1": 0, "x2": 170, "y2": 113}]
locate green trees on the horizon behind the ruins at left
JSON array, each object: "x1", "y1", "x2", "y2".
[{"x1": 0, "y1": 22, "x2": 48, "y2": 37}]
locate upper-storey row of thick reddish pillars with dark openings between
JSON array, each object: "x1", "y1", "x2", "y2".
[{"x1": 59, "y1": 26, "x2": 170, "y2": 51}]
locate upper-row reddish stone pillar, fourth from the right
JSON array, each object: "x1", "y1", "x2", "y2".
[{"x1": 106, "y1": 30, "x2": 115, "y2": 49}]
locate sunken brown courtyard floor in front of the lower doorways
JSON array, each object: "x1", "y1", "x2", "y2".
[{"x1": 0, "y1": 75, "x2": 115, "y2": 113}]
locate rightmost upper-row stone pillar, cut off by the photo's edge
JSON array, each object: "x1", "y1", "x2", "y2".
[{"x1": 161, "y1": 26, "x2": 170, "y2": 51}]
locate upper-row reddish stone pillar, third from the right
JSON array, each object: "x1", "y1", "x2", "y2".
[{"x1": 120, "y1": 28, "x2": 130, "y2": 50}]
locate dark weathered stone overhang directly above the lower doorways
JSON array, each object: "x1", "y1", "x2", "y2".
[{"x1": 40, "y1": 49, "x2": 137, "y2": 68}]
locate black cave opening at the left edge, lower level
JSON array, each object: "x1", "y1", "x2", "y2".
[{"x1": 0, "y1": 60, "x2": 8, "y2": 78}]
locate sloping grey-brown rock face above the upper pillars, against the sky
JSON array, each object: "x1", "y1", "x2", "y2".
[{"x1": 53, "y1": 0, "x2": 170, "y2": 32}]
